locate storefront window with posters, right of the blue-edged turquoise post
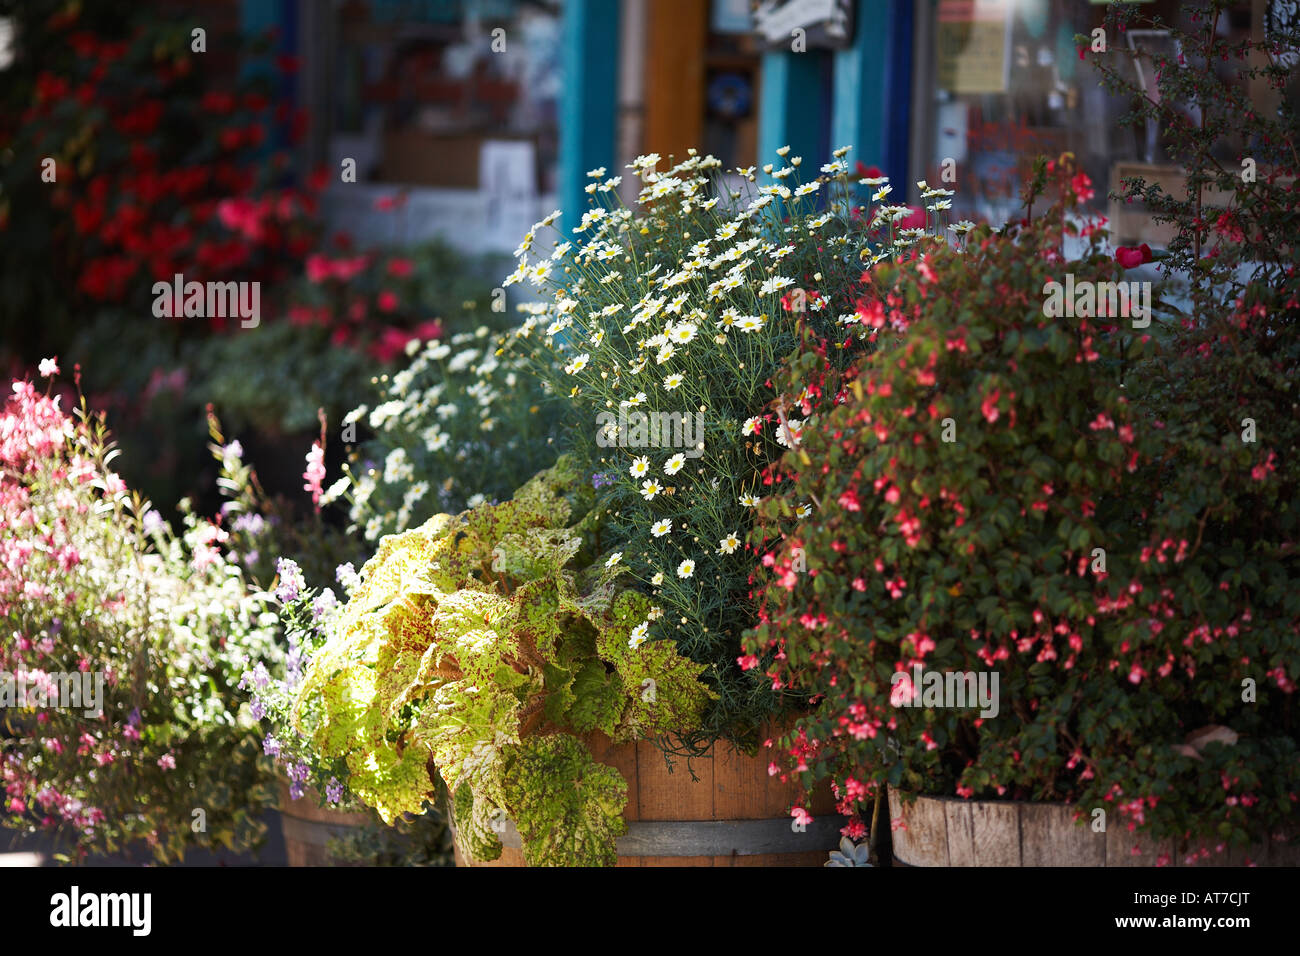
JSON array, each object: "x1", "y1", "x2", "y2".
[{"x1": 914, "y1": 0, "x2": 1262, "y2": 242}]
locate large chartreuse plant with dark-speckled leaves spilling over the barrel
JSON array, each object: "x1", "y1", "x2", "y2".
[{"x1": 295, "y1": 460, "x2": 712, "y2": 865}]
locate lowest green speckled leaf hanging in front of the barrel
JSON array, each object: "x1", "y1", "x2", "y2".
[{"x1": 502, "y1": 734, "x2": 628, "y2": 866}]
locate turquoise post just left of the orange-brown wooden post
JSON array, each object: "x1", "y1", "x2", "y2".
[{"x1": 558, "y1": 0, "x2": 621, "y2": 237}]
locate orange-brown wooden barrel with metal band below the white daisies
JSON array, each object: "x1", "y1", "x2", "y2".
[{"x1": 455, "y1": 735, "x2": 844, "y2": 866}]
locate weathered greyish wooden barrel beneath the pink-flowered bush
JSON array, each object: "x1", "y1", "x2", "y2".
[{"x1": 889, "y1": 791, "x2": 1300, "y2": 866}]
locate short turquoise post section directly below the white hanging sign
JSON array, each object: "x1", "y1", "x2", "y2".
[{"x1": 758, "y1": 49, "x2": 826, "y2": 170}]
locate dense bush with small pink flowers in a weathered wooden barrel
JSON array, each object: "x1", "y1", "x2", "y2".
[{"x1": 746, "y1": 151, "x2": 1300, "y2": 866}]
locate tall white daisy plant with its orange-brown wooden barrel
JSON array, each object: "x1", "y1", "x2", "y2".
[{"x1": 282, "y1": 143, "x2": 948, "y2": 862}]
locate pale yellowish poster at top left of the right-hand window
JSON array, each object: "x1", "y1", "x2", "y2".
[{"x1": 935, "y1": 0, "x2": 1011, "y2": 94}]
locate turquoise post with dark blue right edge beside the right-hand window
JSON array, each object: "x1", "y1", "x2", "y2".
[{"x1": 831, "y1": 0, "x2": 913, "y2": 188}]
